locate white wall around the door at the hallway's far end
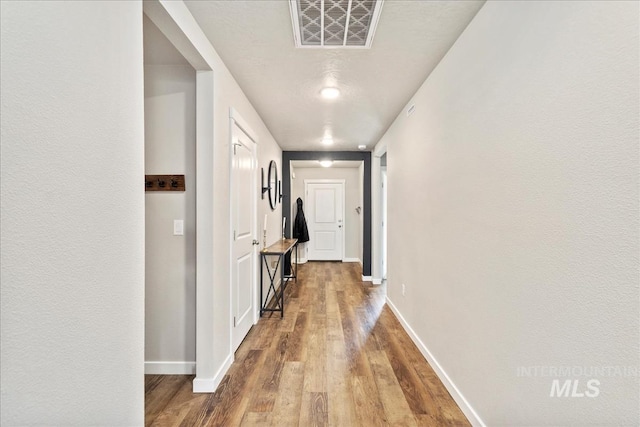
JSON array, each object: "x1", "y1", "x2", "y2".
[{"x1": 291, "y1": 167, "x2": 362, "y2": 261}]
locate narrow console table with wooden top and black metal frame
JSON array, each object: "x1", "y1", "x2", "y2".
[{"x1": 260, "y1": 239, "x2": 298, "y2": 317}]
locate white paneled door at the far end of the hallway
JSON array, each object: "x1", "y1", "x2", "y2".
[{"x1": 305, "y1": 180, "x2": 344, "y2": 261}]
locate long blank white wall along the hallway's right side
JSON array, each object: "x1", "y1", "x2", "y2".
[{"x1": 381, "y1": 1, "x2": 640, "y2": 426}]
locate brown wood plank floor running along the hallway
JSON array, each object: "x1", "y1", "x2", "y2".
[{"x1": 145, "y1": 262, "x2": 469, "y2": 427}]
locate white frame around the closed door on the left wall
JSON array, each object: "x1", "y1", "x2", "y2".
[{"x1": 228, "y1": 107, "x2": 260, "y2": 354}]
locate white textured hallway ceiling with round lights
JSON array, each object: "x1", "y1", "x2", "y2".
[{"x1": 185, "y1": 0, "x2": 483, "y2": 150}]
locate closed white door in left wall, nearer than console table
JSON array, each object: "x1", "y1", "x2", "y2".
[{"x1": 231, "y1": 122, "x2": 257, "y2": 351}]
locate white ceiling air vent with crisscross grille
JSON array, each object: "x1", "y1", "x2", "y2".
[{"x1": 289, "y1": 0, "x2": 383, "y2": 49}]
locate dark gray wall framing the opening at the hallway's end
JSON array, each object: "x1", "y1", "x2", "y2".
[{"x1": 282, "y1": 151, "x2": 371, "y2": 276}]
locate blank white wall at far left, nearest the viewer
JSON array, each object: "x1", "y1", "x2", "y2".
[{"x1": 0, "y1": 1, "x2": 144, "y2": 426}]
